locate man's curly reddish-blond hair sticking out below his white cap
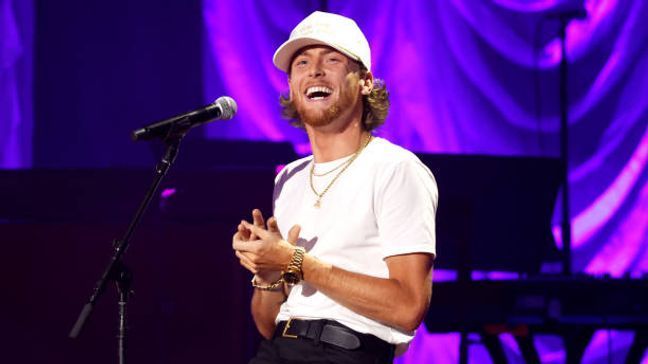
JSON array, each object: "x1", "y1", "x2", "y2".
[{"x1": 279, "y1": 69, "x2": 389, "y2": 131}]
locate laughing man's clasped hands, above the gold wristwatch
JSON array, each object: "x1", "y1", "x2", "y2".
[{"x1": 232, "y1": 209, "x2": 300, "y2": 283}]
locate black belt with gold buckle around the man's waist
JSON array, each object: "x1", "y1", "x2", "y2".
[{"x1": 274, "y1": 319, "x2": 395, "y2": 354}]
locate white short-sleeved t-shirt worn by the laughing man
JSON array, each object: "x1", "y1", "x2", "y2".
[{"x1": 274, "y1": 138, "x2": 438, "y2": 344}]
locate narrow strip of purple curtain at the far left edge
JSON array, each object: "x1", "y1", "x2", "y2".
[{"x1": 0, "y1": 0, "x2": 33, "y2": 168}]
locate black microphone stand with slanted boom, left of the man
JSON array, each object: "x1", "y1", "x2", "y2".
[{"x1": 69, "y1": 128, "x2": 188, "y2": 364}]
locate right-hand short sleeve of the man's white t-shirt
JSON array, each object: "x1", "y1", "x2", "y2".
[{"x1": 375, "y1": 159, "x2": 439, "y2": 258}]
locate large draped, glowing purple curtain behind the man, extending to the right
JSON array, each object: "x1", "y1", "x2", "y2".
[{"x1": 204, "y1": 0, "x2": 648, "y2": 363}]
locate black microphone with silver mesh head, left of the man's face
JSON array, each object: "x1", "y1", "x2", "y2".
[{"x1": 131, "y1": 96, "x2": 237, "y2": 141}]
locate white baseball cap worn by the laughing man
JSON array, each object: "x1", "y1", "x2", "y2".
[{"x1": 272, "y1": 11, "x2": 371, "y2": 73}]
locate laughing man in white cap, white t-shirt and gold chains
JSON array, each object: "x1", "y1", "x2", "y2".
[{"x1": 233, "y1": 12, "x2": 437, "y2": 364}]
